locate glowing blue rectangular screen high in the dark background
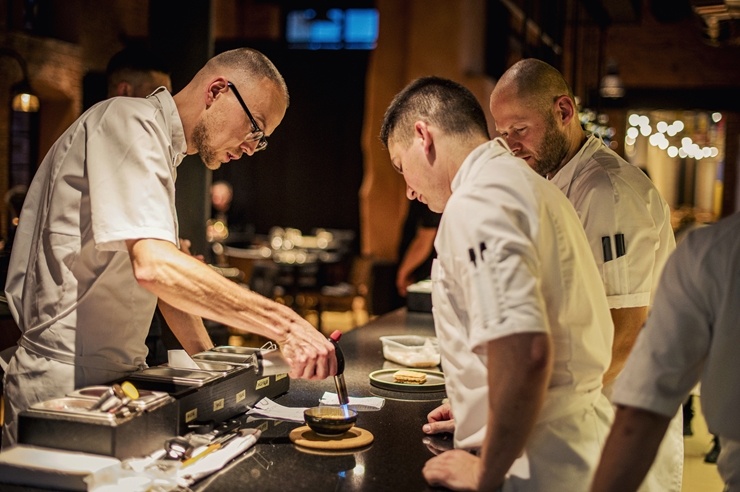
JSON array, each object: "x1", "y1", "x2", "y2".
[{"x1": 285, "y1": 8, "x2": 379, "y2": 50}]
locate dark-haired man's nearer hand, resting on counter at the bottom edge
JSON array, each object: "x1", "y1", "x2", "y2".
[{"x1": 422, "y1": 449, "x2": 482, "y2": 490}]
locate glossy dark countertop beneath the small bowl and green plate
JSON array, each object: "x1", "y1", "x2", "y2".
[{"x1": 192, "y1": 309, "x2": 451, "y2": 492}]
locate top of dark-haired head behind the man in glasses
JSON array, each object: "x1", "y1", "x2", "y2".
[{"x1": 105, "y1": 46, "x2": 172, "y2": 97}]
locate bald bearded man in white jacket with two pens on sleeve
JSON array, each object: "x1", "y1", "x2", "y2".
[{"x1": 490, "y1": 58, "x2": 683, "y2": 492}]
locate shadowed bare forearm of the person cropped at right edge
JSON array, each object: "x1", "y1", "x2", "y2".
[{"x1": 591, "y1": 407, "x2": 671, "y2": 492}]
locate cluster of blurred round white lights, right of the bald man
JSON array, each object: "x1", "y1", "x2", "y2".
[{"x1": 624, "y1": 113, "x2": 722, "y2": 160}]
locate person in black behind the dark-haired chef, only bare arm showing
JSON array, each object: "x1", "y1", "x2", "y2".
[{"x1": 394, "y1": 200, "x2": 442, "y2": 309}]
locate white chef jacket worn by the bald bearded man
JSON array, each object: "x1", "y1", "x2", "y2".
[{"x1": 551, "y1": 135, "x2": 676, "y2": 309}]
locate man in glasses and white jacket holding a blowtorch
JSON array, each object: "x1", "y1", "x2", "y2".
[{"x1": 3, "y1": 48, "x2": 336, "y2": 447}]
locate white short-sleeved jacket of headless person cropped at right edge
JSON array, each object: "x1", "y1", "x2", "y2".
[{"x1": 613, "y1": 213, "x2": 740, "y2": 490}]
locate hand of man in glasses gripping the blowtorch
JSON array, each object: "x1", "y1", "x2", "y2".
[{"x1": 278, "y1": 317, "x2": 337, "y2": 379}]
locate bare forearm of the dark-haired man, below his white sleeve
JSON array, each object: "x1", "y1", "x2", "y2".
[{"x1": 480, "y1": 334, "x2": 552, "y2": 490}]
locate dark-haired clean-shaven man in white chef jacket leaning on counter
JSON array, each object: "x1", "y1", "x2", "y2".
[{"x1": 381, "y1": 77, "x2": 613, "y2": 492}]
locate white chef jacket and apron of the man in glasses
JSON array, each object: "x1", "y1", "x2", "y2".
[{"x1": 4, "y1": 88, "x2": 186, "y2": 442}]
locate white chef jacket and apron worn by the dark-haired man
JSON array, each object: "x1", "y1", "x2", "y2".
[{"x1": 432, "y1": 139, "x2": 613, "y2": 492}]
